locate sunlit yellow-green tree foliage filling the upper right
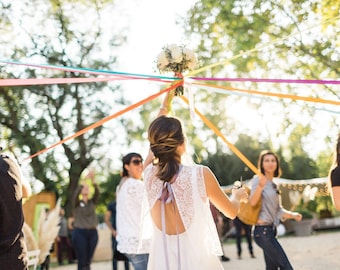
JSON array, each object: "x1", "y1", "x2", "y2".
[{"x1": 183, "y1": 0, "x2": 340, "y2": 166}]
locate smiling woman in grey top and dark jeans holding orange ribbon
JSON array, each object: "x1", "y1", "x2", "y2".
[{"x1": 250, "y1": 150, "x2": 302, "y2": 270}]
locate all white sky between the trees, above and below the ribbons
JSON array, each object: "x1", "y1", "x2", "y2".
[{"x1": 97, "y1": 0, "x2": 196, "y2": 168}]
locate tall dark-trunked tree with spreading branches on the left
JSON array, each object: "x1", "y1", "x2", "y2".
[{"x1": 0, "y1": 0, "x2": 125, "y2": 213}]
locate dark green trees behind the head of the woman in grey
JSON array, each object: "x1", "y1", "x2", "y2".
[{"x1": 202, "y1": 128, "x2": 329, "y2": 185}]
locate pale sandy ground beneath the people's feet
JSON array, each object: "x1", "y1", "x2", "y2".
[{"x1": 51, "y1": 231, "x2": 340, "y2": 270}]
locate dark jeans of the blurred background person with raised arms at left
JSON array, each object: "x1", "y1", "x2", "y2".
[{"x1": 72, "y1": 228, "x2": 98, "y2": 270}]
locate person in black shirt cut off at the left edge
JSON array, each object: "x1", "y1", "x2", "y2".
[{"x1": 0, "y1": 154, "x2": 31, "y2": 270}]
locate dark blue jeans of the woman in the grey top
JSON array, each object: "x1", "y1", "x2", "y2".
[{"x1": 254, "y1": 225, "x2": 293, "y2": 270}]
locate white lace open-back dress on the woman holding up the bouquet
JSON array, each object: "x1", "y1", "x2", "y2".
[{"x1": 144, "y1": 164, "x2": 223, "y2": 270}]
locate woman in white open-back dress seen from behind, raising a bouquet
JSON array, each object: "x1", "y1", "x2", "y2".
[{"x1": 144, "y1": 91, "x2": 248, "y2": 270}]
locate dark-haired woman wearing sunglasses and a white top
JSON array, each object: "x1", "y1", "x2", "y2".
[{"x1": 116, "y1": 153, "x2": 149, "y2": 270}]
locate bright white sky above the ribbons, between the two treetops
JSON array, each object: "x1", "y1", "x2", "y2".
[{"x1": 115, "y1": 0, "x2": 195, "y2": 74}]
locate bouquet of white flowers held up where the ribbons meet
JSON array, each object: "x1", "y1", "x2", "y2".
[{"x1": 157, "y1": 44, "x2": 198, "y2": 96}]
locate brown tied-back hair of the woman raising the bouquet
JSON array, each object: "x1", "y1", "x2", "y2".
[{"x1": 148, "y1": 115, "x2": 184, "y2": 182}]
